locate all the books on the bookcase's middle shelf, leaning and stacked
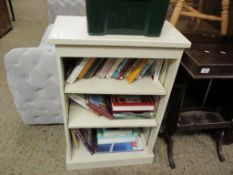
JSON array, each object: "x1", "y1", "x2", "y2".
[{"x1": 68, "y1": 94, "x2": 158, "y2": 120}]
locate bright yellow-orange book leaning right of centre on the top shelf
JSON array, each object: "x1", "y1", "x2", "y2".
[{"x1": 126, "y1": 59, "x2": 147, "y2": 83}]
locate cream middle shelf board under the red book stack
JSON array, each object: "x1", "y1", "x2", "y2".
[{"x1": 68, "y1": 102, "x2": 157, "y2": 129}]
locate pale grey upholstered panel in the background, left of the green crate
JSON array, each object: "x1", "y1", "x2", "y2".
[{"x1": 48, "y1": 0, "x2": 86, "y2": 23}]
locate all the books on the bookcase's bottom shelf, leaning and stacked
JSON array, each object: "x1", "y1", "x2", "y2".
[{"x1": 71, "y1": 128, "x2": 144, "y2": 154}]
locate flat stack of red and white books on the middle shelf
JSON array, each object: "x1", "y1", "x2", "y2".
[{"x1": 111, "y1": 95, "x2": 158, "y2": 119}]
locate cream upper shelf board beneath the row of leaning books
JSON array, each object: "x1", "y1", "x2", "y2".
[{"x1": 65, "y1": 77, "x2": 166, "y2": 95}]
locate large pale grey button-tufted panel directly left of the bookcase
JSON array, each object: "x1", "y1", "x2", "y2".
[{"x1": 4, "y1": 46, "x2": 63, "y2": 124}]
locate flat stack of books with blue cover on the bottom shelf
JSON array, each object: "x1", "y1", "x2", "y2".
[{"x1": 96, "y1": 128, "x2": 144, "y2": 153}]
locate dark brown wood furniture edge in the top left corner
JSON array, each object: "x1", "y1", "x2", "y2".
[{"x1": 0, "y1": 0, "x2": 13, "y2": 38}]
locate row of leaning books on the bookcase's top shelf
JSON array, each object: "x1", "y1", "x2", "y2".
[{"x1": 66, "y1": 58, "x2": 163, "y2": 84}]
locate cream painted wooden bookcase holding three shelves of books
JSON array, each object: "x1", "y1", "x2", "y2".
[{"x1": 49, "y1": 16, "x2": 191, "y2": 170}]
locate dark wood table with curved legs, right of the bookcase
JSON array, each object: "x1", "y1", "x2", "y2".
[{"x1": 164, "y1": 34, "x2": 233, "y2": 168}]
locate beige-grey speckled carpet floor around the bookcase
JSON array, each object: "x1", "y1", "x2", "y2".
[{"x1": 0, "y1": 0, "x2": 233, "y2": 175}]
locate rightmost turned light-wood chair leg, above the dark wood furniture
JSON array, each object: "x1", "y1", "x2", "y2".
[{"x1": 221, "y1": 0, "x2": 230, "y2": 35}]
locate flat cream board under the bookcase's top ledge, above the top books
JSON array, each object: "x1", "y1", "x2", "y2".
[{"x1": 57, "y1": 46, "x2": 182, "y2": 59}]
